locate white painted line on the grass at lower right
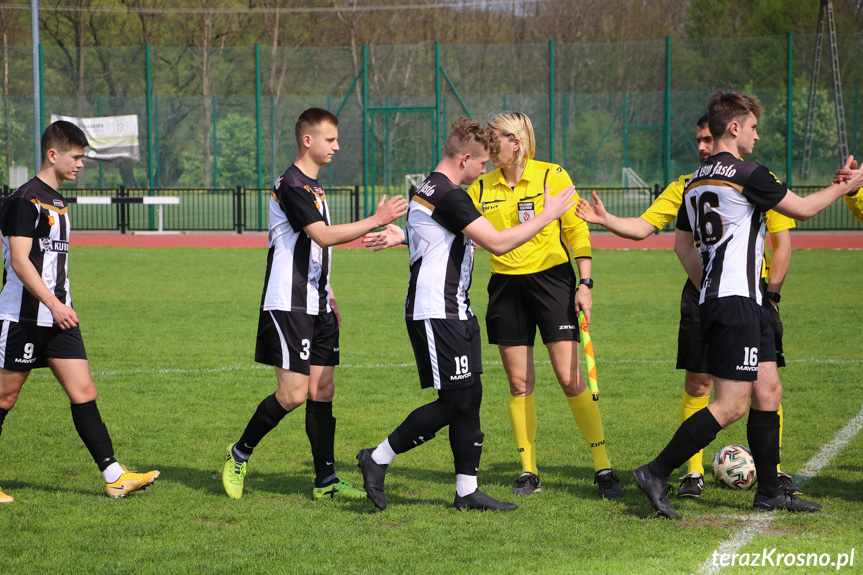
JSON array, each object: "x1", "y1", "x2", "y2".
[{"x1": 698, "y1": 409, "x2": 863, "y2": 575}]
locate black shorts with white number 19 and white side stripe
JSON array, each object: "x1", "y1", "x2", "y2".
[{"x1": 406, "y1": 316, "x2": 482, "y2": 389}]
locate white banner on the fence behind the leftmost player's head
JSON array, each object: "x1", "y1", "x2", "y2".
[{"x1": 51, "y1": 114, "x2": 141, "y2": 162}]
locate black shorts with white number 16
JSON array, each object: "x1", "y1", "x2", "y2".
[{"x1": 701, "y1": 296, "x2": 776, "y2": 381}]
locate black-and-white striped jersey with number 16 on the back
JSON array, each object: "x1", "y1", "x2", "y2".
[{"x1": 677, "y1": 152, "x2": 787, "y2": 305}]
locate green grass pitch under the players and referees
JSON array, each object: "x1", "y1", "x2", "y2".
[{"x1": 0, "y1": 247, "x2": 863, "y2": 574}]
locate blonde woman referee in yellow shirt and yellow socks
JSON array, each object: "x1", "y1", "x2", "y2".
[{"x1": 468, "y1": 112, "x2": 621, "y2": 499}]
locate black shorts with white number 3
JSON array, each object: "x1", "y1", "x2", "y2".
[{"x1": 255, "y1": 310, "x2": 339, "y2": 375}]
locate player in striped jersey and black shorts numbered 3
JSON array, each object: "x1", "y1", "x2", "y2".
[{"x1": 222, "y1": 108, "x2": 407, "y2": 500}]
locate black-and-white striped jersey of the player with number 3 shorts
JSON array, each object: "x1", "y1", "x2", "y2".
[{"x1": 261, "y1": 164, "x2": 333, "y2": 315}]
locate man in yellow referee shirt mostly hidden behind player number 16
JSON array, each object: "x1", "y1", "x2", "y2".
[{"x1": 578, "y1": 114, "x2": 800, "y2": 497}]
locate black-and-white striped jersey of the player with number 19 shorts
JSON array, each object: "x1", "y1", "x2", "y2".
[{"x1": 405, "y1": 172, "x2": 482, "y2": 320}]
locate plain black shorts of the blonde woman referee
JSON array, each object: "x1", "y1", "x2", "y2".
[{"x1": 485, "y1": 263, "x2": 581, "y2": 347}]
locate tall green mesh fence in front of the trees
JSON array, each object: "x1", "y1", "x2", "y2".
[{"x1": 0, "y1": 34, "x2": 863, "y2": 216}]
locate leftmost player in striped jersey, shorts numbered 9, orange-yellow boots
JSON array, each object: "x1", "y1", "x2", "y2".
[{"x1": 0, "y1": 121, "x2": 159, "y2": 503}]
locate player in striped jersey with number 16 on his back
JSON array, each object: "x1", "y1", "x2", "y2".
[{"x1": 633, "y1": 92, "x2": 863, "y2": 518}]
